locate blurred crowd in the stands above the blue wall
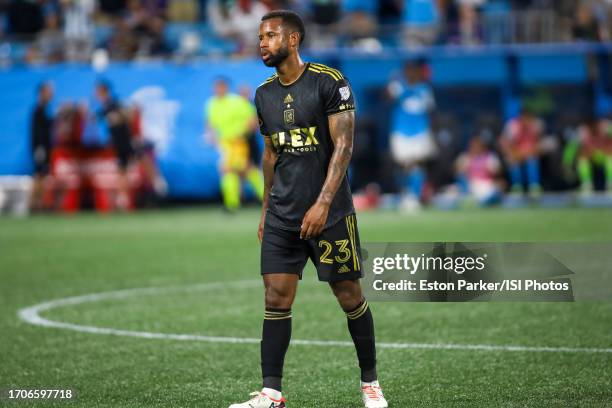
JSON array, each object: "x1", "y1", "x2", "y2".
[{"x1": 0, "y1": 0, "x2": 612, "y2": 65}]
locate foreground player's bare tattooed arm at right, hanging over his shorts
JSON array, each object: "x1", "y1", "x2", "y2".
[{"x1": 300, "y1": 111, "x2": 355, "y2": 239}]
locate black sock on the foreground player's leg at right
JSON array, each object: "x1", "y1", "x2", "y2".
[{"x1": 346, "y1": 299, "x2": 377, "y2": 382}]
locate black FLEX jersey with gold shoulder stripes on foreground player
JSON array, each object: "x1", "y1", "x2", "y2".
[{"x1": 255, "y1": 63, "x2": 355, "y2": 230}]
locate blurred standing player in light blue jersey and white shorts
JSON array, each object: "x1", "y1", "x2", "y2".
[{"x1": 387, "y1": 62, "x2": 436, "y2": 209}]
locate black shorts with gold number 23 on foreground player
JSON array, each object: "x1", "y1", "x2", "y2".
[{"x1": 261, "y1": 215, "x2": 363, "y2": 282}]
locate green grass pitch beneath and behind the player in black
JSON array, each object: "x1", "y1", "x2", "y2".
[{"x1": 0, "y1": 208, "x2": 612, "y2": 408}]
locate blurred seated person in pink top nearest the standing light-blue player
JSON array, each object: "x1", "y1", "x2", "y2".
[{"x1": 456, "y1": 136, "x2": 501, "y2": 206}]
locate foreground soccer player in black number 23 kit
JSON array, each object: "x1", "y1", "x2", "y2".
[{"x1": 230, "y1": 10, "x2": 388, "y2": 408}]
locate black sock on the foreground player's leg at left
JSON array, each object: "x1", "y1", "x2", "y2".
[{"x1": 261, "y1": 308, "x2": 291, "y2": 392}]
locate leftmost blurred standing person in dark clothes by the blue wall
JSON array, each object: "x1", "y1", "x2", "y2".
[{"x1": 30, "y1": 82, "x2": 53, "y2": 210}]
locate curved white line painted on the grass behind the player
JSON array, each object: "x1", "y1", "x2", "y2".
[{"x1": 17, "y1": 280, "x2": 612, "y2": 353}]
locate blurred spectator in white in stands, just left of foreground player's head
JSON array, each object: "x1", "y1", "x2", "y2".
[{"x1": 207, "y1": 0, "x2": 268, "y2": 54}]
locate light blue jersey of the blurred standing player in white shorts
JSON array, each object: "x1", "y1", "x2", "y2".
[{"x1": 389, "y1": 80, "x2": 434, "y2": 137}]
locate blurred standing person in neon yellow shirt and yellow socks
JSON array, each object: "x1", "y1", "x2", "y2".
[{"x1": 206, "y1": 78, "x2": 263, "y2": 212}]
